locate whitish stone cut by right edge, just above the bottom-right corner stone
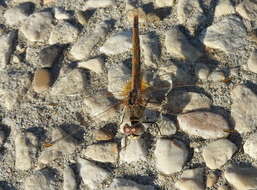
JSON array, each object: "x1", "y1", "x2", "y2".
[{"x1": 244, "y1": 133, "x2": 257, "y2": 160}]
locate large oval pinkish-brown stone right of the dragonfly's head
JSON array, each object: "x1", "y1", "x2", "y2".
[{"x1": 177, "y1": 111, "x2": 229, "y2": 139}]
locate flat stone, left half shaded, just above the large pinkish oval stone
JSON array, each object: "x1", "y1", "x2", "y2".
[{"x1": 166, "y1": 90, "x2": 212, "y2": 114}]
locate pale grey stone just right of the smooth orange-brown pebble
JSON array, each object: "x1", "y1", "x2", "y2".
[{"x1": 50, "y1": 69, "x2": 85, "y2": 96}]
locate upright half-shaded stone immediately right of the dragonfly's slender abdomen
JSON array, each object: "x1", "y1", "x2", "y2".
[{"x1": 140, "y1": 33, "x2": 161, "y2": 67}]
